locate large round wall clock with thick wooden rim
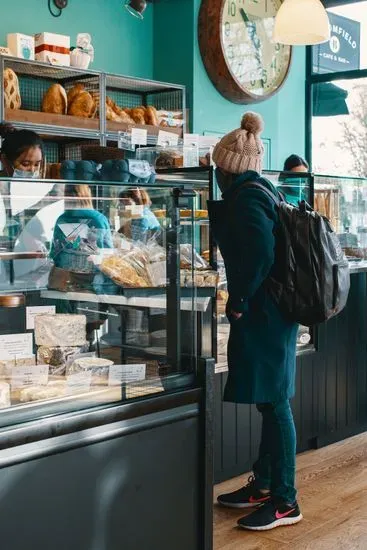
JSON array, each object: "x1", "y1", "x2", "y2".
[{"x1": 199, "y1": 0, "x2": 292, "y2": 103}]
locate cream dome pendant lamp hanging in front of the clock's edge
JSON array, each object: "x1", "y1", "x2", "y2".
[{"x1": 273, "y1": 0, "x2": 330, "y2": 46}]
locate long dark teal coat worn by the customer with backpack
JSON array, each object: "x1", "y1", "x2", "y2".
[{"x1": 223, "y1": 172, "x2": 298, "y2": 403}]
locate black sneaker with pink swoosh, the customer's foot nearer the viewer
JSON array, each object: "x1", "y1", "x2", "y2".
[{"x1": 237, "y1": 501, "x2": 303, "y2": 531}]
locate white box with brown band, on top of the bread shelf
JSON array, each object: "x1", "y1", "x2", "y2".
[{"x1": 34, "y1": 32, "x2": 70, "y2": 67}]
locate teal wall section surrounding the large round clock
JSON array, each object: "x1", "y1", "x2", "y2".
[{"x1": 154, "y1": 0, "x2": 305, "y2": 169}]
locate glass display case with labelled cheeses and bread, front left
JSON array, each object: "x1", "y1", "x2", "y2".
[{"x1": 0, "y1": 177, "x2": 217, "y2": 425}]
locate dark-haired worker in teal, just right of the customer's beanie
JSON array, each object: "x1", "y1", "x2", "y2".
[{"x1": 278, "y1": 155, "x2": 309, "y2": 206}]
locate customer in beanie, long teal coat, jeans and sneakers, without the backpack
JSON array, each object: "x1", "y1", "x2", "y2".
[{"x1": 213, "y1": 113, "x2": 302, "y2": 530}]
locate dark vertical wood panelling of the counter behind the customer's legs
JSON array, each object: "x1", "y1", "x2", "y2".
[{"x1": 215, "y1": 273, "x2": 367, "y2": 482}]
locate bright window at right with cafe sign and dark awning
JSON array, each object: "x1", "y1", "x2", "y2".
[{"x1": 307, "y1": 1, "x2": 367, "y2": 177}]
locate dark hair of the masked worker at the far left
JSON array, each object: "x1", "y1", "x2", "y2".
[{"x1": 0, "y1": 124, "x2": 44, "y2": 162}]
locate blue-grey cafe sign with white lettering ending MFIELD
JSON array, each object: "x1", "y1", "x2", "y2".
[{"x1": 312, "y1": 12, "x2": 361, "y2": 73}]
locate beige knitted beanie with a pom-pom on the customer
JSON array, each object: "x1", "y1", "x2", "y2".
[{"x1": 213, "y1": 112, "x2": 264, "y2": 174}]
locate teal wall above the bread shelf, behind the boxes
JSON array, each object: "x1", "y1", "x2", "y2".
[{"x1": 0, "y1": 0, "x2": 153, "y2": 78}]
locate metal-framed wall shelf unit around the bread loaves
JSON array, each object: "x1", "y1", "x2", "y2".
[{"x1": 0, "y1": 56, "x2": 186, "y2": 145}]
